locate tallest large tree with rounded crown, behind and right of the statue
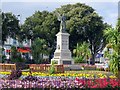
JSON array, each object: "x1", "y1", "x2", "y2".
[{"x1": 56, "y1": 3, "x2": 107, "y2": 64}]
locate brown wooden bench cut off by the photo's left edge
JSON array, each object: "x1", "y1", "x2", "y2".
[{"x1": 0, "y1": 63, "x2": 16, "y2": 71}]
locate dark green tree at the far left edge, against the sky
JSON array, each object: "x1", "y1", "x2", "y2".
[{"x1": 2, "y1": 13, "x2": 20, "y2": 44}]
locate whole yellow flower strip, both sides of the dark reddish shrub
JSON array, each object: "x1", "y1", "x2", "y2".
[{"x1": 0, "y1": 72, "x2": 117, "y2": 79}]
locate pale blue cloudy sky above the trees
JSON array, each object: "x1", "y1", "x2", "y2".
[{"x1": 2, "y1": 0, "x2": 118, "y2": 27}]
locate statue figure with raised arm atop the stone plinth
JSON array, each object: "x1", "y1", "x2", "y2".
[{"x1": 56, "y1": 12, "x2": 66, "y2": 33}]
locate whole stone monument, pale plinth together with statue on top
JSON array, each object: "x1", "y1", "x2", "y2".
[{"x1": 51, "y1": 13, "x2": 74, "y2": 65}]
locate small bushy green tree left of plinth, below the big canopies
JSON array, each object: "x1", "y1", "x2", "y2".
[{"x1": 32, "y1": 38, "x2": 48, "y2": 63}]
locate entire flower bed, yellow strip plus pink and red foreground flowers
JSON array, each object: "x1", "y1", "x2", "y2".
[{"x1": 0, "y1": 72, "x2": 120, "y2": 90}]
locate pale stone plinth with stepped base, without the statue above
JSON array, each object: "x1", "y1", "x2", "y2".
[{"x1": 51, "y1": 32, "x2": 74, "y2": 65}]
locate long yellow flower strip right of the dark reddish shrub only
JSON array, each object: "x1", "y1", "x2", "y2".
[{"x1": 22, "y1": 72, "x2": 117, "y2": 79}]
